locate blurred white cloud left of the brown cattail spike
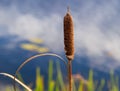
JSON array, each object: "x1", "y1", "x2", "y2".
[{"x1": 0, "y1": 7, "x2": 63, "y2": 51}]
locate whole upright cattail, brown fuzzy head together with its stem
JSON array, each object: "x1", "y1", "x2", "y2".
[{"x1": 64, "y1": 7, "x2": 74, "y2": 91}]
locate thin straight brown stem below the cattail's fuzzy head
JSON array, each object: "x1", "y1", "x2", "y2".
[{"x1": 68, "y1": 61, "x2": 72, "y2": 91}]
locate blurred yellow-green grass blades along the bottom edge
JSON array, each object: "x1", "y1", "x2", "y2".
[{"x1": 6, "y1": 61, "x2": 120, "y2": 91}]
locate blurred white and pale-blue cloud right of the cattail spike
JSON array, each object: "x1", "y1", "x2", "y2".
[{"x1": 75, "y1": 0, "x2": 120, "y2": 68}]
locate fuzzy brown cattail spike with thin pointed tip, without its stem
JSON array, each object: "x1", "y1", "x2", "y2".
[{"x1": 64, "y1": 7, "x2": 74, "y2": 61}]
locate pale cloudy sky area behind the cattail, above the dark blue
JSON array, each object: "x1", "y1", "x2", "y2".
[{"x1": 0, "y1": 0, "x2": 120, "y2": 66}]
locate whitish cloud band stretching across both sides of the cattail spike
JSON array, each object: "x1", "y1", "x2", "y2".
[{"x1": 0, "y1": 0, "x2": 120, "y2": 69}]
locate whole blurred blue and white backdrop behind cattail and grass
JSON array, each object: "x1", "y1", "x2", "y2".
[{"x1": 0, "y1": 0, "x2": 120, "y2": 88}]
